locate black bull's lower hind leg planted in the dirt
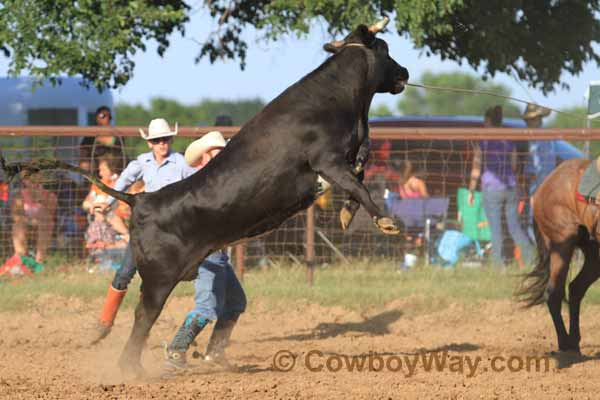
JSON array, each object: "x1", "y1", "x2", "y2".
[{"x1": 119, "y1": 283, "x2": 175, "y2": 376}]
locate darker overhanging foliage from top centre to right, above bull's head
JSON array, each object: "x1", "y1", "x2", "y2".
[{"x1": 202, "y1": 0, "x2": 600, "y2": 92}]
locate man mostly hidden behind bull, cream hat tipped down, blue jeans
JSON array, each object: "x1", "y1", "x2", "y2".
[{"x1": 165, "y1": 131, "x2": 246, "y2": 372}]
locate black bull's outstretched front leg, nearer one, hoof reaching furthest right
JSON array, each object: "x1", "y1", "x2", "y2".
[{"x1": 310, "y1": 154, "x2": 400, "y2": 235}]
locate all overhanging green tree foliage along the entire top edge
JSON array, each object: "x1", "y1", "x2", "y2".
[{"x1": 0, "y1": 0, "x2": 600, "y2": 91}]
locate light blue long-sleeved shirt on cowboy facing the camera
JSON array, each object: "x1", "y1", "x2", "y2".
[{"x1": 110, "y1": 151, "x2": 197, "y2": 203}]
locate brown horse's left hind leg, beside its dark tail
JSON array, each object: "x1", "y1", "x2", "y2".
[{"x1": 546, "y1": 240, "x2": 575, "y2": 351}]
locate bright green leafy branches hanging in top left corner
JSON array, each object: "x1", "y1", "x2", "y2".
[{"x1": 0, "y1": 0, "x2": 189, "y2": 89}]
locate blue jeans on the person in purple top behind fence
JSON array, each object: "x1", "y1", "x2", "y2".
[{"x1": 482, "y1": 189, "x2": 534, "y2": 266}]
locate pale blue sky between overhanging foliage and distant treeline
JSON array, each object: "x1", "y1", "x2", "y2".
[{"x1": 0, "y1": 9, "x2": 600, "y2": 113}]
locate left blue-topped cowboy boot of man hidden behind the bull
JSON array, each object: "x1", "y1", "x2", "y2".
[{"x1": 164, "y1": 314, "x2": 209, "y2": 373}]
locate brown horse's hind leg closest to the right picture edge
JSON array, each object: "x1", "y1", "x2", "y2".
[{"x1": 569, "y1": 240, "x2": 600, "y2": 352}]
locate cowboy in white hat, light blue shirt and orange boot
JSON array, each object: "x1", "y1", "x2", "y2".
[{"x1": 92, "y1": 118, "x2": 196, "y2": 343}]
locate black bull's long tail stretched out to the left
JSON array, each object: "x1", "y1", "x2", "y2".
[{"x1": 0, "y1": 154, "x2": 135, "y2": 207}]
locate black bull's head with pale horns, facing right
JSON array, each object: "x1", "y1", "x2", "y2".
[{"x1": 323, "y1": 17, "x2": 408, "y2": 94}]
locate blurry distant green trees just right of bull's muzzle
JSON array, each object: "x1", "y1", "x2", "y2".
[{"x1": 398, "y1": 72, "x2": 520, "y2": 118}]
